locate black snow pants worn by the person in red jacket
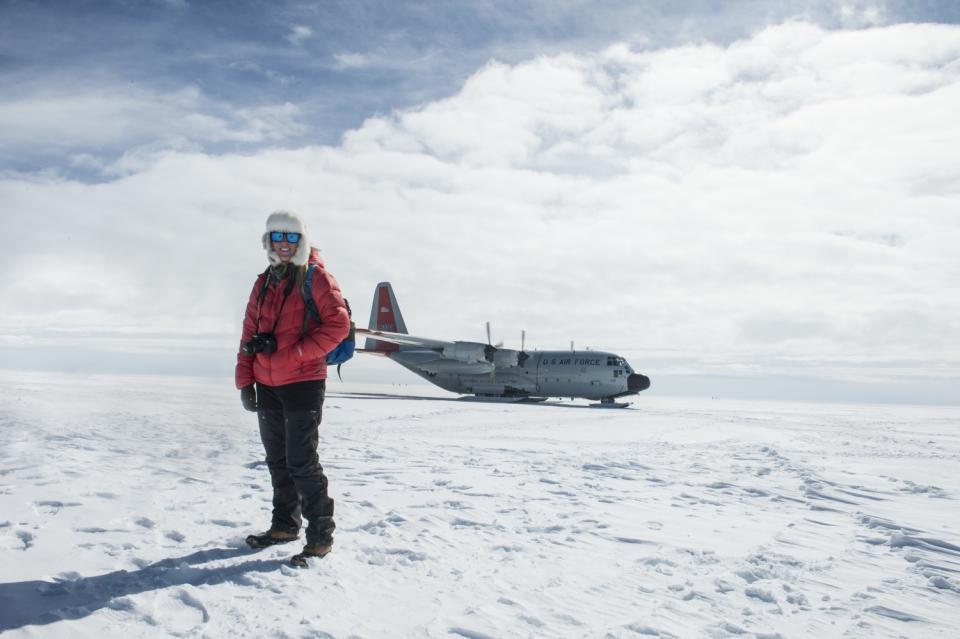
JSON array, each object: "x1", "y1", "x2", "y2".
[{"x1": 257, "y1": 380, "x2": 335, "y2": 544}]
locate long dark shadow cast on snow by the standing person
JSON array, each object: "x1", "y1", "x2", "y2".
[{"x1": 0, "y1": 548, "x2": 286, "y2": 632}]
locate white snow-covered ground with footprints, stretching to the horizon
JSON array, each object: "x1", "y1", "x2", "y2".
[{"x1": 0, "y1": 371, "x2": 960, "y2": 639}]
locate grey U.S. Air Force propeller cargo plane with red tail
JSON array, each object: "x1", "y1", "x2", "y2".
[{"x1": 356, "y1": 282, "x2": 650, "y2": 408}]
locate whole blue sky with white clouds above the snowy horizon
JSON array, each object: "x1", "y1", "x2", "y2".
[{"x1": 0, "y1": 0, "x2": 960, "y2": 403}]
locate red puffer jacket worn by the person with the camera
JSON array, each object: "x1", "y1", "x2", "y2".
[{"x1": 236, "y1": 248, "x2": 350, "y2": 388}]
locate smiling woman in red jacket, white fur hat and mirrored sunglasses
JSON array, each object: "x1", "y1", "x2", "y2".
[{"x1": 236, "y1": 211, "x2": 350, "y2": 566}]
